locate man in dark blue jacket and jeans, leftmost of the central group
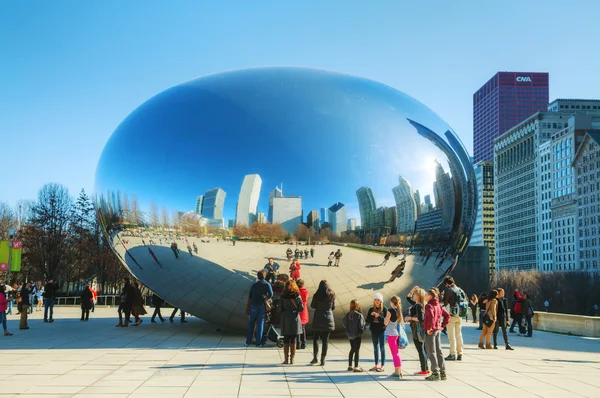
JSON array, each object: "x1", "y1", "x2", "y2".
[{"x1": 246, "y1": 270, "x2": 273, "y2": 347}]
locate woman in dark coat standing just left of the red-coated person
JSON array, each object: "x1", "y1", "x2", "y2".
[{"x1": 278, "y1": 279, "x2": 304, "y2": 365}]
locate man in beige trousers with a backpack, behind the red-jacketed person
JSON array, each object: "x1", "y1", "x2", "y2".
[{"x1": 443, "y1": 276, "x2": 467, "y2": 361}]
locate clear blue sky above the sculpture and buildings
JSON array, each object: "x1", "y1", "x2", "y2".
[{"x1": 0, "y1": 0, "x2": 600, "y2": 203}]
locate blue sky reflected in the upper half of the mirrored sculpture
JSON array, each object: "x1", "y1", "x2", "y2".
[{"x1": 96, "y1": 68, "x2": 468, "y2": 224}]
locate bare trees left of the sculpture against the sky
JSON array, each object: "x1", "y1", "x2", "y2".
[{"x1": 0, "y1": 184, "x2": 127, "y2": 293}]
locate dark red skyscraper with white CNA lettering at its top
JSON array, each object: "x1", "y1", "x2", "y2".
[{"x1": 473, "y1": 72, "x2": 548, "y2": 163}]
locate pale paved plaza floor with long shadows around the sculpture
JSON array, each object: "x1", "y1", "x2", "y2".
[{"x1": 0, "y1": 307, "x2": 600, "y2": 398}]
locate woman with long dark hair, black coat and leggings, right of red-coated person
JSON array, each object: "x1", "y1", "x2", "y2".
[{"x1": 310, "y1": 280, "x2": 335, "y2": 366}]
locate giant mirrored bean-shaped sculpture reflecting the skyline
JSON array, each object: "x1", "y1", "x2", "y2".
[{"x1": 95, "y1": 68, "x2": 476, "y2": 330}]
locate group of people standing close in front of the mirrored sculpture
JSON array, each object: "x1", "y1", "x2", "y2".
[{"x1": 245, "y1": 272, "x2": 476, "y2": 381}]
